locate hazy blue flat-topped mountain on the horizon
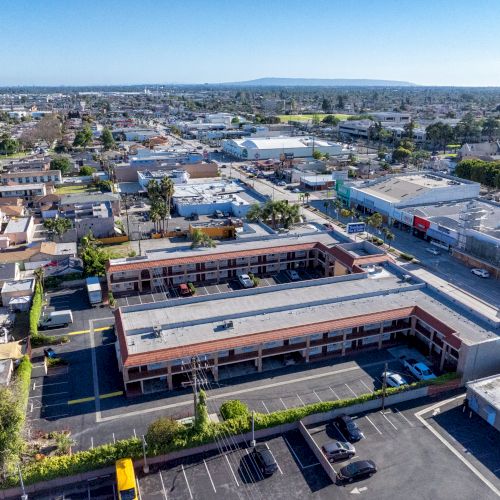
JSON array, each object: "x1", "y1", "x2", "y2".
[{"x1": 219, "y1": 78, "x2": 416, "y2": 87}]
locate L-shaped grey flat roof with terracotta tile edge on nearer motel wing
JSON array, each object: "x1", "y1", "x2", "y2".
[{"x1": 115, "y1": 263, "x2": 500, "y2": 367}]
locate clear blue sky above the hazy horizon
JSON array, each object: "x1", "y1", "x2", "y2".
[{"x1": 0, "y1": 0, "x2": 500, "y2": 86}]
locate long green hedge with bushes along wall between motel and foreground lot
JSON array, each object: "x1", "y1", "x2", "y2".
[{"x1": 0, "y1": 373, "x2": 459, "y2": 490}]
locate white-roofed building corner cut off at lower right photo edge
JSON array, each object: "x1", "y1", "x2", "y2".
[{"x1": 467, "y1": 375, "x2": 500, "y2": 431}]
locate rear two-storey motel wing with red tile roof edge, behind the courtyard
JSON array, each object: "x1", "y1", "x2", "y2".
[{"x1": 106, "y1": 234, "x2": 388, "y2": 296}]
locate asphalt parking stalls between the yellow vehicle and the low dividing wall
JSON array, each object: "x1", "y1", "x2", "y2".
[{"x1": 139, "y1": 431, "x2": 332, "y2": 500}]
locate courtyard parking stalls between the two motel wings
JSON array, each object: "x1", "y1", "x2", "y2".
[{"x1": 116, "y1": 269, "x2": 321, "y2": 307}]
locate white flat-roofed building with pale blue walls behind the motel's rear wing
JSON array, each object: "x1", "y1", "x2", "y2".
[{"x1": 172, "y1": 179, "x2": 264, "y2": 218}]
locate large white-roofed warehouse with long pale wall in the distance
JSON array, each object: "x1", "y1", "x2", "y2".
[{"x1": 223, "y1": 136, "x2": 348, "y2": 160}]
